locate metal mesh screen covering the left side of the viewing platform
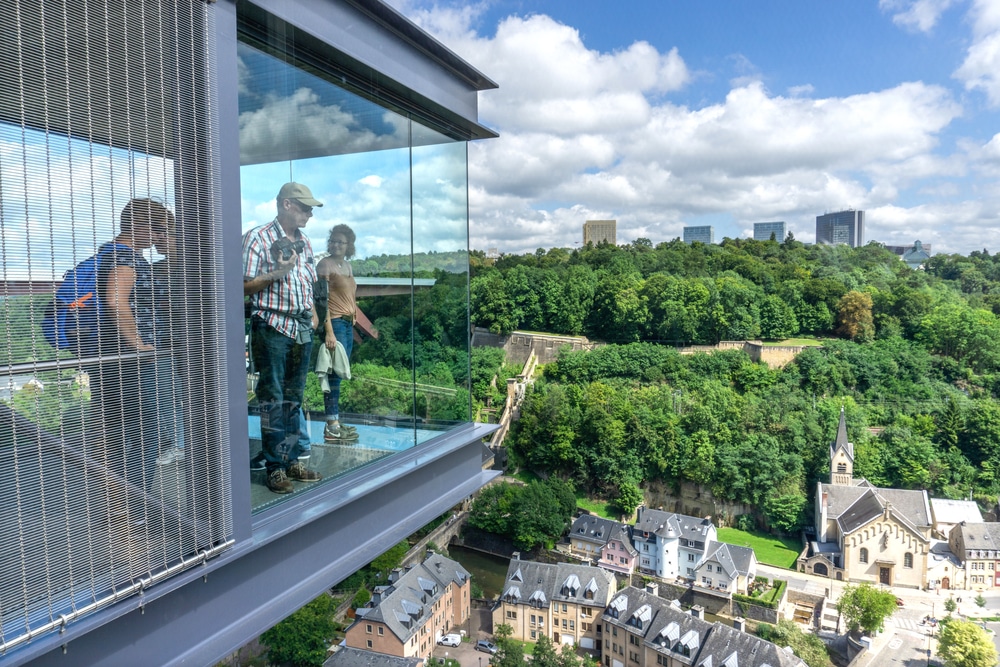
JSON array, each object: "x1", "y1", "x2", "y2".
[{"x1": 0, "y1": 0, "x2": 232, "y2": 656}]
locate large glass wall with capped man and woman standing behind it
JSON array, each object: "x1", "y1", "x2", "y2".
[{"x1": 238, "y1": 5, "x2": 471, "y2": 509}]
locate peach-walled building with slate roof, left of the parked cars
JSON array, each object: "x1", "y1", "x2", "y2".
[{"x1": 344, "y1": 553, "x2": 472, "y2": 658}]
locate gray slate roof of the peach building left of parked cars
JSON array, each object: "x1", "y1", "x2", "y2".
[{"x1": 355, "y1": 552, "x2": 469, "y2": 643}]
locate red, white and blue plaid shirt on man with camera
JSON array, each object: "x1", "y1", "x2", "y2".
[{"x1": 243, "y1": 219, "x2": 316, "y2": 338}]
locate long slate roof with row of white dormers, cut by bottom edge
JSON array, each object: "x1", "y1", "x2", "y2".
[{"x1": 602, "y1": 586, "x2": 805, "y2": 667}]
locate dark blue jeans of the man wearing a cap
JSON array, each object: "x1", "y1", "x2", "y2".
[{"x1": 250, "y1": 317, "x2": 312, "y2": 473}]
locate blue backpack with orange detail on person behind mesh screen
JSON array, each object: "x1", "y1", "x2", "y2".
[{"x1": 42, "y1": 243, "x2": 128, "y2": 357}]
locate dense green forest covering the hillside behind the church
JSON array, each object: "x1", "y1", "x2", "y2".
[{"x1": 472, "y1": 237, "x2": 1000, "y2": 531}]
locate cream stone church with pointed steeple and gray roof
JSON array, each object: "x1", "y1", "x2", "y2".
[{"x1": 798, "y1": 409, "x2": 933, "y2": 588}]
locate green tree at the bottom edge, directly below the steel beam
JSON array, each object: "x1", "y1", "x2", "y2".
[{"x1": 260, "y1": 593, "x2": 337, "y2": 667}]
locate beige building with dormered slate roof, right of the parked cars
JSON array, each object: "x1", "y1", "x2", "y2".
[{"x1": 493, "y1": 554, "x2": 616, "y2": 650}]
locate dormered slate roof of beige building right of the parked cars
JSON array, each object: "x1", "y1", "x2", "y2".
[{"x1": 500, "y1": 558, "x2": 616, "y2": 608}]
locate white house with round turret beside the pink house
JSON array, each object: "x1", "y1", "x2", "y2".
[{"x1": 632, "y1": 507, "x2": 717, "y2": 580}]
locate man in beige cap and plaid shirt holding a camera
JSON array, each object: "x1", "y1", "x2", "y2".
[{"x1": 243, "y1": 183, "x2": 323, "y2": 493}]
